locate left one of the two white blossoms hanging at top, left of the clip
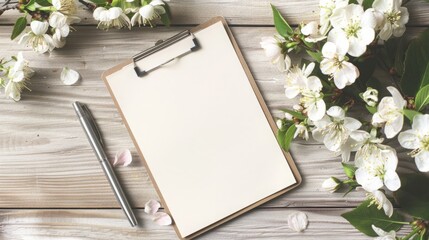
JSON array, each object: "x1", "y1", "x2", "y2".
[{"x1": 93, "y1": 7, "x2": 131, "y2": 30}]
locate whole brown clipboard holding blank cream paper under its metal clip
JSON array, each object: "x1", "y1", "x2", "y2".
[{"x1": 102, "y1": 17, "x2": 302, "y2": 239}]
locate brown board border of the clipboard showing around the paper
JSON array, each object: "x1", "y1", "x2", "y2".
[{"x1": 101, "y1": 16, "x2": 302, "y2": 240}]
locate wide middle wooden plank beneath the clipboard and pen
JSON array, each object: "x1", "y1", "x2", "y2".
[{"x1": 0, "y1": 26, "x2": 421, "y2": 208}]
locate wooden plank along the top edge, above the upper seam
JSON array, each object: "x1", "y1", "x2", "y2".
[{"x1": 0, "y1": 0, "x2": 429, "y2": 26}]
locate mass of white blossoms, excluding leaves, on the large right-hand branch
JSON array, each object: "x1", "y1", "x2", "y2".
[{"x1": 261, "y1": 0, "x2": 422, "y2": 219}]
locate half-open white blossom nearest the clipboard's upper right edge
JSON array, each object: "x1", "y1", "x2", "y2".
[{"x1": 260, "y1": 36, "x2": 292, "y2": 72}]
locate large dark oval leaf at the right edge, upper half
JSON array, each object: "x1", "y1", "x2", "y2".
[{"x1": 401, "y1": 29, "x2": 429, "y2": 96}]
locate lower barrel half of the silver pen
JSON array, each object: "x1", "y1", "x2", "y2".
[{"x1": 101, "y1": 160, "x2": 137, "y2": 227}]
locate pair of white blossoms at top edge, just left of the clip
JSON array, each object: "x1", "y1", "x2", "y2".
[{"x1": 93, "y1": 0, "x2": 166, "y2": 30}]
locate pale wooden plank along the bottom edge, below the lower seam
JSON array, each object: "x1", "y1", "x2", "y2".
[{"x1": 0, "y1": 208, "x2": 409, "y2": 240}]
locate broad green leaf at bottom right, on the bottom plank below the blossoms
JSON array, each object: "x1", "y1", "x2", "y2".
[{"x1": 341, "y1": 200, "x2": 403, "y2": 237}]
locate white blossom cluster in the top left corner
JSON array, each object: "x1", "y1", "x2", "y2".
[{"x1": 19, "y1": 0, "x2": 80, "y2": 53}]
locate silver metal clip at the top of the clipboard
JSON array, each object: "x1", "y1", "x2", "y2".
[{"x1": 133, "y1": 30, "x2": 199, "y2": 77}]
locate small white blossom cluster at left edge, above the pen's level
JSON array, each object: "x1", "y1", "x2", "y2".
[{"x1": 0, "y1": 52, "x2": 34, "y2": 101}]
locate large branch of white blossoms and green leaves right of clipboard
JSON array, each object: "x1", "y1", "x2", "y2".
[{"x1": 261, "y1": 0, "x2": 429, "y2": 240}]
